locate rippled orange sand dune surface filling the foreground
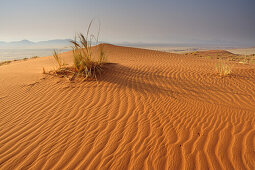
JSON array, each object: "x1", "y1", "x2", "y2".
[{"x1": 0, "y1": 45, "x2": 255, "y2": 170}]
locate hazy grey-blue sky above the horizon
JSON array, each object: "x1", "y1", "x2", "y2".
[{"x1": 0, "y1": 0, "x2": 255, "y2": 45}]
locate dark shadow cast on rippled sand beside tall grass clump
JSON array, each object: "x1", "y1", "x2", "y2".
[{"x1": 98, "y1": 63, "x2": 178, "y2": 98}]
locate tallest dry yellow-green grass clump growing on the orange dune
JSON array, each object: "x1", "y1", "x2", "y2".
[{"x1": 53, "y1": 20, "x2": 106, "y2": 80}]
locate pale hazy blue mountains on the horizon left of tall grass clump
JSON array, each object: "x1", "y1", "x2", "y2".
[{"x1": 0, "y1": 39, "x2": 71, "y2": 49}]
